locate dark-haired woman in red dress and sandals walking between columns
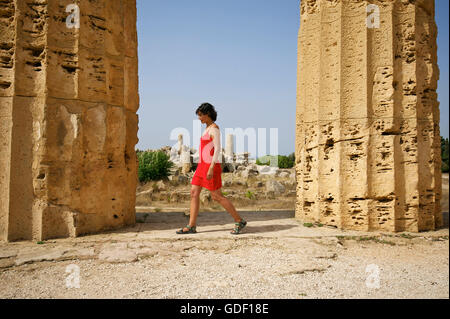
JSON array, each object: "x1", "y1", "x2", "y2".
[{"x1": 177, "y1": 103, "x2": 247, "y2": 235}]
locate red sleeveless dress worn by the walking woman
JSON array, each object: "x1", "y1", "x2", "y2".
[{"x1": 191, "y1": 129, "x2": 222, "y2": 191}]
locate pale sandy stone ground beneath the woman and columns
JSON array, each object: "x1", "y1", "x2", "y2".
[{"x1": 0, "y1": 211, "x2": 449, "y2": 299}]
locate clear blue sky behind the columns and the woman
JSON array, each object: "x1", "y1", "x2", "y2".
[{"x1": 137, "y1": 0, "x2": 449, "y2": 157}]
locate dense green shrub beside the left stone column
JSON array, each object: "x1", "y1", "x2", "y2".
[{"x1": 138, "y1": 151, "x2": 175, "y2": 182}]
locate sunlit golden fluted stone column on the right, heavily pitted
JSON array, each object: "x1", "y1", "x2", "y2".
[{"x1": 296, "y1": 0, "x2": 442, "y2": 231}]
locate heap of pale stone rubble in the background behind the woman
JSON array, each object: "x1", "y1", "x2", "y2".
[{"x1": 137, "y1": 137, "x2": 296, "y2": 206}]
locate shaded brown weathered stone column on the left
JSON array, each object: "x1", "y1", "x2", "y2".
[{"x1": 0, "y1": 0, "x2": 139, "y2": 241}]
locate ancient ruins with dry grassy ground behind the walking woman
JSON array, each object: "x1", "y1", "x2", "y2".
[{"x1": 136, "y1": 138, "x2": 296, "y2": 215}]
